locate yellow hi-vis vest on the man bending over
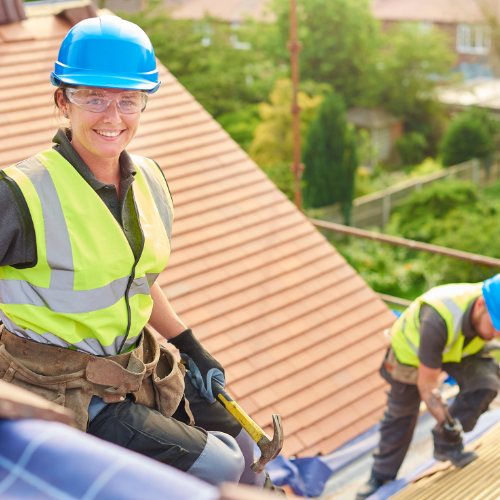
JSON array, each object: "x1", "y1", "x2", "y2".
[{"x1": 391, "y1": 283, "x2": 484, "y2": 366}]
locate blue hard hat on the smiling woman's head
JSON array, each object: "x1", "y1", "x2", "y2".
[{"x1": 50, "y1": 16, "x2": 161, "y2": 94}]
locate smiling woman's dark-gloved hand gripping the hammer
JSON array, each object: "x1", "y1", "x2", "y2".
[{"x1": 169, "y1": 329, "x2": 226, "y2": 403}]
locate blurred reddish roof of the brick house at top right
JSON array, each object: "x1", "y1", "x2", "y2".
[{"x1": 372, "y1": 0, "x2": 492, "y2": 24}]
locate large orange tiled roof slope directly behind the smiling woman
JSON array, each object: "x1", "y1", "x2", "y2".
[{"x1": 0, "y1": 12, "x2": 394, "y2": 455}]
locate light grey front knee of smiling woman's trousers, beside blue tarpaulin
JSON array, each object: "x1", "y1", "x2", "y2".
[{"x1": 187, "y1": 431, "x2": 245, "y2": 484}]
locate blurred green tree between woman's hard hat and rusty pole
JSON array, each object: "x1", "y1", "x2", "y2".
[{"x1": 120, "y1": 2, "x2": 280, "y2": 117}]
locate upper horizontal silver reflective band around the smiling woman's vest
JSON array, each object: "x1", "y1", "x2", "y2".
[{"x1": 0, "y1": 276, "x2": 149, "y2": 314}]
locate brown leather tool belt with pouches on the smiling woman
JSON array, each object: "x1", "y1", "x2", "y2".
[{"x1": 0, "y1": 325, "x2": 194, "y2": 431}]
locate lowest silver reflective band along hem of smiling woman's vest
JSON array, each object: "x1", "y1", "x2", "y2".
[{"x1": 0, "y1": 310, "x2": 139, "y2": 356}]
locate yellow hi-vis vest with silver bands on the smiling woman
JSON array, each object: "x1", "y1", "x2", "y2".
[{"x1": 0, "y1": 149, "x2": 173, "y2": 356}]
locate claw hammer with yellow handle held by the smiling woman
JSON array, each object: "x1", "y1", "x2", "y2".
[{"x1": 212, "y1": 380, "x2": 283, "y2": 474}]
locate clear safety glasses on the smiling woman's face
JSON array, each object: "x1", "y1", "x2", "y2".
[{"x1": 65, "y1": 88, "x2": 148, "y2": 114}]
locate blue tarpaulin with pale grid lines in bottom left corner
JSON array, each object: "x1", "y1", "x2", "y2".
[{"x1": 0, "y1": 420, "x2": 220, "y2": 500}]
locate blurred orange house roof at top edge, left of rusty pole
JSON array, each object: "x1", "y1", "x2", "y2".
[{"x1": 164, "y1": 0, "x2": 274, "y2": 23}]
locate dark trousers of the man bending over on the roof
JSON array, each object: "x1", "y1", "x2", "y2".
[{"x1": 372, "y1": 354, "x2": 500, "y2": 481}]
